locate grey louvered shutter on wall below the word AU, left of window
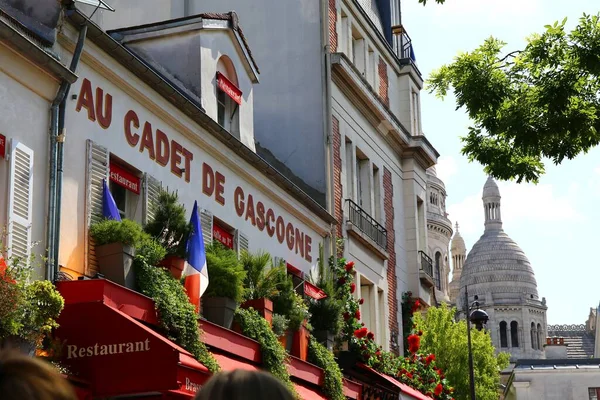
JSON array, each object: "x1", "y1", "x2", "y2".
[{"x1": 84, "y1": 139, "x2": 110, "y2": 276}]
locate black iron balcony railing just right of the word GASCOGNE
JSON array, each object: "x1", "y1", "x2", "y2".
[{"x1": 346, "y1": 199, "x2": 388, "y2": 259}]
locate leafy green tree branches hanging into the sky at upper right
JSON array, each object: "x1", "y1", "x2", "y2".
[{"x1": 428, "y1": 14, "x2": 600, "y2": 183}]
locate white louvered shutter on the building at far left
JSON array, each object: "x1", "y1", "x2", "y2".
[{"x1": 6, "y1": 141, "x2": 33, "y2": 263}]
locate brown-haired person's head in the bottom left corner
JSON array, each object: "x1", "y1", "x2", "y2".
[{"x1": 0, "y1": 351, "x2": 77, "y2": 400}]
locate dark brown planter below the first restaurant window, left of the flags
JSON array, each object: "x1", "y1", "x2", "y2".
[{"x1": 96, "y1": 243, "x2": 135, "y2": 290}]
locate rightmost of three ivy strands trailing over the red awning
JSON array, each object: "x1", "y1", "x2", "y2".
[{"x1": 308, "y1": 336, "x2": 346, "y2": 400}]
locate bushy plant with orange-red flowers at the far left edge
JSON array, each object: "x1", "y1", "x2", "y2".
[{"x1": 0, "y1": 257, "x2": 64, "y2": 356}]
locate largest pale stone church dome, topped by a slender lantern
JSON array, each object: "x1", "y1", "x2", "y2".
[{"x1": 457, "y1": 177, "x2": 548, "y2": 361}]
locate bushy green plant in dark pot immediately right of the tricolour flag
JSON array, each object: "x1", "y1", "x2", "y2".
[{"x1": 202, "y1": 242, "x2": 246, "y2": 329}]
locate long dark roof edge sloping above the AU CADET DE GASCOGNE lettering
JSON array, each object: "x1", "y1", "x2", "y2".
[{"x1": 68, "y1": 11, "x2": 337, "y2": 224}]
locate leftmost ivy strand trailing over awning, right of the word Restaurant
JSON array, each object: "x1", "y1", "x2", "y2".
[{"x1": 134, "y1": 256, "x2": 220, "y2": 373}]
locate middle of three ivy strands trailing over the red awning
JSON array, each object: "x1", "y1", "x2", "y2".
[{"x1": 235, "y1": 308, "x2": 300, "y2": 399}]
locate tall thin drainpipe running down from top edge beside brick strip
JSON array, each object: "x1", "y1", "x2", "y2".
[{"x1": 321, "y1": 0, "x2": 341, "y2": 265}]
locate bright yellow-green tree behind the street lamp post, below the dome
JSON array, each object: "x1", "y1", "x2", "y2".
[{"x1": 414, "y1": 304, "x2": 509, "y2": 400}]
